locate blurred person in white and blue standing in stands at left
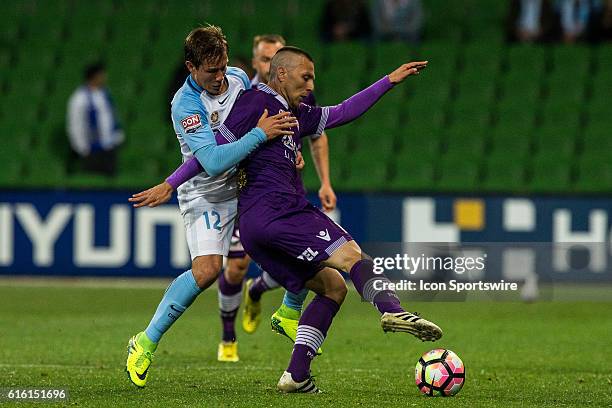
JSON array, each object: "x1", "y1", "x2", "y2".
[{"x1": 66, "y1": 62, "x2": 125, "y2": 176}]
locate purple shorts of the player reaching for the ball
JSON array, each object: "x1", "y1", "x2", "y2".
[{"x1": 239, "y1": 193, "x2": 353, "y2": 293}]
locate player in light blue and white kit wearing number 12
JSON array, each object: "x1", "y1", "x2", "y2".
[{"x1": 126, "y1": 26, "x2": 296, "y2": 387}]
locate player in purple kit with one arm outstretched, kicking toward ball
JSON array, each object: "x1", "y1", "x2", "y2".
[{"x1": 170, "y1": 47, "x2": 442, "y2": 393}]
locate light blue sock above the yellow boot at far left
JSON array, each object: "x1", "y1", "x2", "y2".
[{"x1": 145, "y1": 269, "x2": 202, "y2": 343}]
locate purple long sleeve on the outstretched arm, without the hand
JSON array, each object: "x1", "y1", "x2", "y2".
[{"x1": 326, "y1": 75, "x2": 393, "y2": 131}]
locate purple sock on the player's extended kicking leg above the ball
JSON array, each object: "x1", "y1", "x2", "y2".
[{"x1": 350, "y1": 259, "x2": 404, "y2": 313}]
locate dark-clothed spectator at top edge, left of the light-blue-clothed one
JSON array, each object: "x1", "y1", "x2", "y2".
[{"x1": 321, "y1": 0, "x2": 372, "y2": 41}]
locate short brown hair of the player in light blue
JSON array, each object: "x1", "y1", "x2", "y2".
[{"x1": 185, "y1": 25, "x2": 229, "y2": 68}]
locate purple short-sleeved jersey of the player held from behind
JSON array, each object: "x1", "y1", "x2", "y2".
[{"x1": 216, "y1": 84, "x2": 329, "y2": 212}]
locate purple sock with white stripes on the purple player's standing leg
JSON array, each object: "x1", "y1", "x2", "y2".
[{"x1": 287, "y1": 295, "x2": 340, "y2": 382}]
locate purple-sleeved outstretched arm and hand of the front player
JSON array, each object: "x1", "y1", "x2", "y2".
[{"x1": 324, "y1": 61, "x2": 427, "y2": 129}]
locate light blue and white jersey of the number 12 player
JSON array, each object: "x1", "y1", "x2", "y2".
[{"x1": 172, "y1": 67, "x2": 266, "y2": 204}]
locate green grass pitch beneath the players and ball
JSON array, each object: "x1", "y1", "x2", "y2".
[{"x1": 0, "y1": 281, "x2": 612, "y2": 407}]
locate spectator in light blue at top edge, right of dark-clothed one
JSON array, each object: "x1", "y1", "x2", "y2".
[{"x1": 372, "y1": 0, "x2": 423, "y2": 44}]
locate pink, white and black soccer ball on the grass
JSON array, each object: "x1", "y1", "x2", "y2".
[{"x1": 414, "y1": 349, "x2": 465, "y2": 397}]
